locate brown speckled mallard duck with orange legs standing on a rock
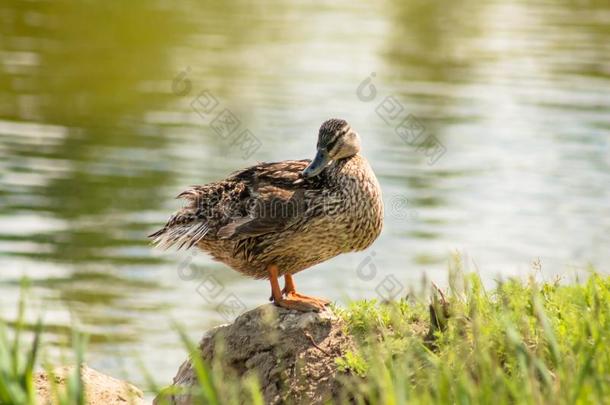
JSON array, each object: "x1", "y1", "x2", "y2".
[{"x1": 150, "y1": 119, "x2": 383, "y2": 311}]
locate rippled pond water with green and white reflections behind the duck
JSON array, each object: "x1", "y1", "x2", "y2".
[{"x1": 0, "y1": 0, "x2": 610, "y2": 386}]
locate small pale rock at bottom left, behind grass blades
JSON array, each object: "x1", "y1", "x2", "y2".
[{"x1": 34, "y1": 366, "x2": 144, "y2": 405}]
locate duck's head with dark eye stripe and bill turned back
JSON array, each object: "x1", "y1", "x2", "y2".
[{"x1": 303, "y1": 118, "x2": 360, "y2": 178}]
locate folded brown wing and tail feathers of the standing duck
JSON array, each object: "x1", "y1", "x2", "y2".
[{"x1": 149, "y1": 160, "x2": 323, "y2": 248}]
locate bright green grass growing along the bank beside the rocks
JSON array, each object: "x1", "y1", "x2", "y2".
[{"x1": 0, "y1": 274, "x2": 610, "y2": 405}]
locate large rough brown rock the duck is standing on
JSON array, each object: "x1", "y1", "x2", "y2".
[{"x1": 157, "y1": 304, "x2": 354, "y2": 405}]
